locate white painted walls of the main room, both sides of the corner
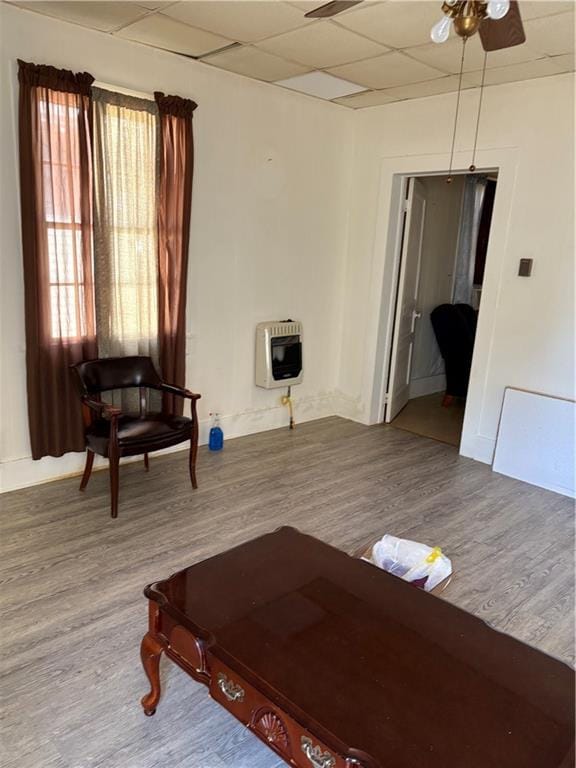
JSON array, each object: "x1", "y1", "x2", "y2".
[{"x1": 0, "y1": 4, "x2": 574, "y2": 488}]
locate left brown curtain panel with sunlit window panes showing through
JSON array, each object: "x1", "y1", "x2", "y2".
[{"x1": 18, "y1": 61, "x2": 97, "y2": 459}]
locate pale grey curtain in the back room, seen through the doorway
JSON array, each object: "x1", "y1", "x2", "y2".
[{"x1": 452, "y1": 175, "x2": 487, "y2": 304}]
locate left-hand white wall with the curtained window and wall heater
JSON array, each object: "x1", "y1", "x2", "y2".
[{"x1": 0, "y1": 4, "x2": 354, "y2": 488}]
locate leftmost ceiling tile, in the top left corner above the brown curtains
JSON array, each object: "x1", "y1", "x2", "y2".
[{"x1": 14, "y1": 0, "x2": 147, "y2": 32}]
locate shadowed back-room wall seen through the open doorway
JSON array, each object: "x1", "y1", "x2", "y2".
[{"x1": 410, "y1": 176, "x2": 464, "y2": 398}]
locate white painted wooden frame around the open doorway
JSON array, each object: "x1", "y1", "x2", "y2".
[{"x1": 364, "y1": 147, "x2": 518, "y2": 463}]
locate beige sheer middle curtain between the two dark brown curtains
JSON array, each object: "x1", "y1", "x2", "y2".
[{"x1": 93, "y1": 88, "x2": 159, "y2": 410}]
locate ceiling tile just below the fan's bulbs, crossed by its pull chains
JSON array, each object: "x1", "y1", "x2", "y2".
[{"x1": 404, "y1": 35, "x2": 542, "y2": 74}]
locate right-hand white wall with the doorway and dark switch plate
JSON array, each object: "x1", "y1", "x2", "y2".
[{"x1": 339, "y1": 75, "x2": 574, "y2": 462}]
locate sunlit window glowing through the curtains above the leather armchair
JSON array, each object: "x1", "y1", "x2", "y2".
[{"x1": 39, "y1": 89, "x2": 158, "y2": 348}]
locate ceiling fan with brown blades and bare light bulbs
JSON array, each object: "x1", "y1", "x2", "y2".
[{"x1": 305, "y1": 0, "x2": 526, "y2": 51}]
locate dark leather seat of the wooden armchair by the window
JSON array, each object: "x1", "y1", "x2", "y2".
[{"x1": 86, "y1": 413, "x2": 192, "y2": 456}]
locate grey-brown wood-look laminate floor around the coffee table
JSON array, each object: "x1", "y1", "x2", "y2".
[{"x1": 0, "y1": 418, "x2": 574, "y2": 768}]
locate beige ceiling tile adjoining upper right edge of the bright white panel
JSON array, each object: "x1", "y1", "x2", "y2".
[{"x1": 329, "y1": 52, "x2": 442, "y2": 89}]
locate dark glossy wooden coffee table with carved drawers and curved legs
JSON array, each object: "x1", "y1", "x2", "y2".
[{"x1": 142, "y1": 528, "x2": 574, "y2": 768}]
